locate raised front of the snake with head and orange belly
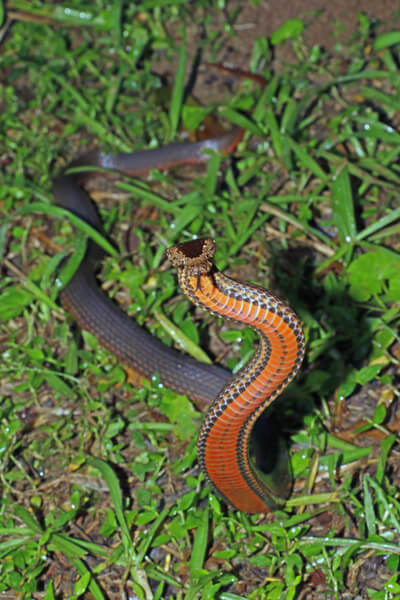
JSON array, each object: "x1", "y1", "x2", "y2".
[{"x1": 167, "y1": 239, "x2": 305, "y2": 513}]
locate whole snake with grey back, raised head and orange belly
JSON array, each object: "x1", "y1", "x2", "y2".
[{"x1": 53, "y1": 127, "x2": 304, "y2": 513}]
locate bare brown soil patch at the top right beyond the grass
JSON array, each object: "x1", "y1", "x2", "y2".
[{"x1": 163, "y1": 0, "x2": 400, "y2": 105}]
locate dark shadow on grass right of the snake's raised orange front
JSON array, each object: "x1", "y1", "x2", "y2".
[{"x1": 252, "y1": 243, "x2": 373, "y2": 487}]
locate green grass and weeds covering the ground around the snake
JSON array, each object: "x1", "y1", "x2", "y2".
[{"x1": 0, "y1": 0, "x2": 400, "y2": 600}]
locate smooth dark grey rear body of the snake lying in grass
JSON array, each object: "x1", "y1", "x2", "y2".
[{"x1": 53, "y1": 128, "x2": 242, "y2": 407}]
